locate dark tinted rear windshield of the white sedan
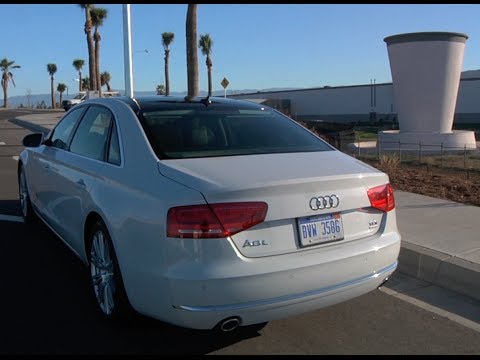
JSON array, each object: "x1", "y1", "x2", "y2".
[{"x1": 139, "y1": 103, "x2": 333, "y2": 159}]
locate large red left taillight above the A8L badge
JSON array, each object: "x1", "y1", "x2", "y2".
[{"x1": 167, "y1": 202, "x2": 268, "y2": 239}]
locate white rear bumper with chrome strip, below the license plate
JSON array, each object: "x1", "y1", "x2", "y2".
[{"x1": 121, "y1": 232, "x2": 400, "y2": 329}]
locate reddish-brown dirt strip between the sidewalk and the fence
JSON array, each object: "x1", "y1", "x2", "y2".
[{"x1": 366, "y1": 161, "x2": 480, "y2": 206}]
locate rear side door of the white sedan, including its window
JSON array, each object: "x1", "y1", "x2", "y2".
[{"x1": 43, "y1": 105, "x2": 113, "y2": 254}]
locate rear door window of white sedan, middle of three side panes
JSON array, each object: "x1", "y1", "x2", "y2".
[{"x1": 70, "y1": 106, "x2": 113, "y2": 160}]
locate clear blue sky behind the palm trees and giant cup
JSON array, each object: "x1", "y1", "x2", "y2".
[{"x1": 0, "y1": 4, "x2": 480, "y2": 96}]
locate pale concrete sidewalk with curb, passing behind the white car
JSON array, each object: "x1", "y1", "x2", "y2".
[{"x1": 12, "y1": 113, "x2": 480, "y2": 300}]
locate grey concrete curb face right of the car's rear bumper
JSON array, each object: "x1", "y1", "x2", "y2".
[{"x1": 397, "y1": 240, "x2": 480, "y2": 300}]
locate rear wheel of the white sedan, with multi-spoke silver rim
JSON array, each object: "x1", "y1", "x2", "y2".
[{"x1": 87, "y1": 220, "x2": 133, "y2": 320}]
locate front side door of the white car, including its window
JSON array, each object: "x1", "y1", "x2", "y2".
[{"x1": 27, "y1": 107, "x2": 86, "y2": 225}]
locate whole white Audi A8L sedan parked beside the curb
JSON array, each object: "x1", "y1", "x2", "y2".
[{"x1": 18, "y1": 96, "x2": 400, "y2": 331}]
